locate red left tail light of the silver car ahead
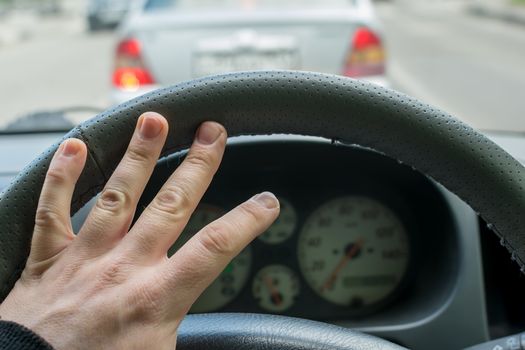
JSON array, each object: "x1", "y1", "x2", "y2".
[{"x1": 113, "y1": 39, "x2": 155, "y2": 91}]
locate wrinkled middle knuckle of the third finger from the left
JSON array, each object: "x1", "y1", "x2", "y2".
[{"x1": 152, "y1": 184, "x2": 192, "y2": 221}]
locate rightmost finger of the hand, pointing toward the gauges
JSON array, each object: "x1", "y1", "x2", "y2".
[{"x1": 161, "y1": 192, "x2": 279, "y2": 310}]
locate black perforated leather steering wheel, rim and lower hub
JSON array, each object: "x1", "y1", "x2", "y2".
[{"x1": 0, "y1": 71, "x2": 525, "y2": 350}]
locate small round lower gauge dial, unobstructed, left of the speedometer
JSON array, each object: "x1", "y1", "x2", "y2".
[{"x1": 252, "y1": 265, "x2": 300, "y2": 312}]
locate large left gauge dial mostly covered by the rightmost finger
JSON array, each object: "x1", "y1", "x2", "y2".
[{"x1": 168, "y1": 205, "x2": 252, "y2": 312}]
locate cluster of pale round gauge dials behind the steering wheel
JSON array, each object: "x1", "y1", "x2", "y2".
[{"x1": 169, "y1": 194, "x2": 411, "y2": 315}]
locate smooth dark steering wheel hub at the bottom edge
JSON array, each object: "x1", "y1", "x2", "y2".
[{"x1": 177, "y1": 314, "x2": 405, "y2": 350}]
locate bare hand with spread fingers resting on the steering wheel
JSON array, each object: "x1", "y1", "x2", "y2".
[{"x1": 0, "y1": 112, "x2": 279, "y2": 349}]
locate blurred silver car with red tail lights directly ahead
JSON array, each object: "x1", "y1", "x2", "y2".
[{"x1": 112, "y1": 0, "x2": 387, "y2": 103}]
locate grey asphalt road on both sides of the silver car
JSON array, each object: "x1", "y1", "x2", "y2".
[{"x1": 0, "y1": 0, "x2": 525, "y2": 131}]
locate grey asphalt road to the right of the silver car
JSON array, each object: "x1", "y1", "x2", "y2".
[{"x1": 377, "y1": 0, "x2": 525, "y2": 132}]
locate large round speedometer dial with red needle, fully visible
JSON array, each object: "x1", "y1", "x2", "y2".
[{"x1": 298, "y1": 196, "x2": 409, "y2": 308}]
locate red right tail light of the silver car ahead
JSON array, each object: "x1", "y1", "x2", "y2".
[{"x1": 343, "y1": 27, "x2": 385, "y2": 77}]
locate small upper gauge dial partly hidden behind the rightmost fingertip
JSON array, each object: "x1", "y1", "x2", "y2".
[{"x1": 259, "y1": 198, "x2": 297, "y2": 244}]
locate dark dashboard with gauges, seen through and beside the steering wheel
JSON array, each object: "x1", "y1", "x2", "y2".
[{"x1": 0, "y1": 134, "x2": 524, "y2": 349}]
